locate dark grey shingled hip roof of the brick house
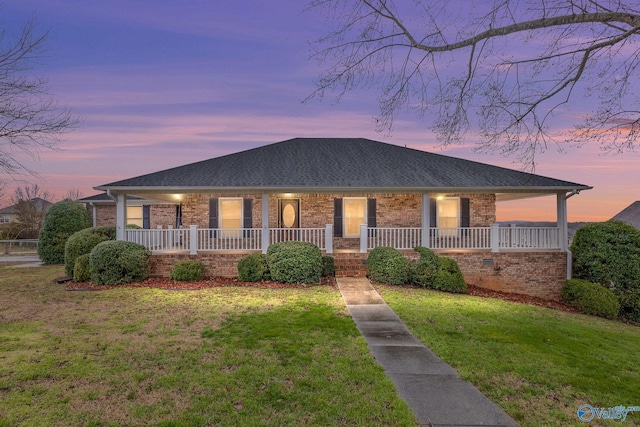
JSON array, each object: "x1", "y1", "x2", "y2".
[{"x1": 95, "y1": 138, "x2": 591, "y2": 193}]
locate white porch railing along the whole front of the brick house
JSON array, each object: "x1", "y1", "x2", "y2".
[{"x1": 125, "y1": 224, "x2": 563, "y2": 254}]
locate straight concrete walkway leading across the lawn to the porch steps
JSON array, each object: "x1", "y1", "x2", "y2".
[{"x1": 337, "y1": 277, "x2": 518, "y2": 426}]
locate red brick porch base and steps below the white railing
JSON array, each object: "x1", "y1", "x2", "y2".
[{"x1": 151, "y1": 251, "x2": 567, "y2": 300}]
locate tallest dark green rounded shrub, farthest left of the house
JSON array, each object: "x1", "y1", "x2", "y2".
[{"x1": 38, "y1": 200, "x2": 91, "y2": 264}]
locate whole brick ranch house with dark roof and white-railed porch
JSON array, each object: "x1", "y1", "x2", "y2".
[{"x1": 95, "y1": 138, "x2": 591, "y2": 299}]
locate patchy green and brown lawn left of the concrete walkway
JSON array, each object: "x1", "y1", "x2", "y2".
[{"x1": 0, "y1": 267, "x2": 415, "y2": 426}]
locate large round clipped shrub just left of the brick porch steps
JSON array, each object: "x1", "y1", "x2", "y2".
[{"x1": 267, "y1": 241, "x2": 322, "y2": 283}]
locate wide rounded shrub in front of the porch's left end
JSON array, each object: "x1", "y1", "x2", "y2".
[{"x1": 89, "y1": 240, "x2": 151, "y2": 285}]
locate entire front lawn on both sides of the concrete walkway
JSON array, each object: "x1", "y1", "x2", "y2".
[{"x1": 0, "y1": 267, "x2": 640, "y2": 426}]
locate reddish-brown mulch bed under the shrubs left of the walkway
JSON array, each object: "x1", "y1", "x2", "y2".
[{"x1": 62, "y1": 277, "x2": 337, "y2": 291}]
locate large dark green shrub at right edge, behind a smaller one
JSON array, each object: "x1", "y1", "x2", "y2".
[{"x1": 571, "y1": 221, "x2": 640, "y2": 320}]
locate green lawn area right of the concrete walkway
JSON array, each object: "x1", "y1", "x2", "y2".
[{"x1": 378, "y1": 285, "x2": 640, "y2": 426}]
